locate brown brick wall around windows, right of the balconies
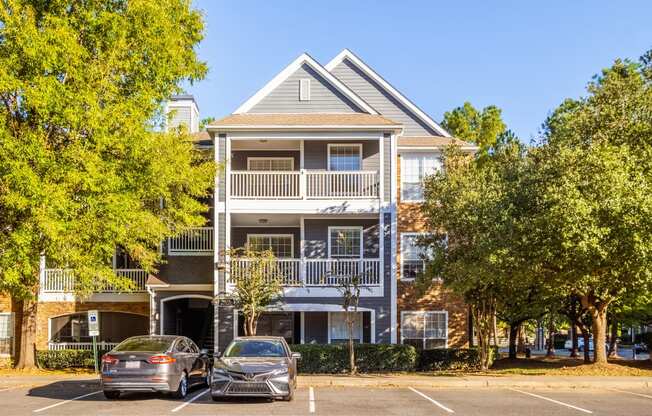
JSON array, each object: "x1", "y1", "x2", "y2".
[{"x1": 396, "y1": 155, "x2": 468, "y2": 347}]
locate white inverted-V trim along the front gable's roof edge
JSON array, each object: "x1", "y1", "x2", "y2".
[{"x1": 233, "y1": 53, "x2": 378, "y2": 114}]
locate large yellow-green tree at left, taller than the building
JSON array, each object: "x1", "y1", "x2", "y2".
[{"x1": 0, "y1": 0, "x2": 215, "y2": 367}]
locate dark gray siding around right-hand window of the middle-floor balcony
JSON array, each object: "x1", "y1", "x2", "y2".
[{"x1": 304, "y1": 217, "x2": 379, "y2": 258}]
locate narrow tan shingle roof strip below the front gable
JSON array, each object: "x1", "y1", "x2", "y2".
[{"x1": 209, "y1": 113, "x2": 400, "y2": 127}]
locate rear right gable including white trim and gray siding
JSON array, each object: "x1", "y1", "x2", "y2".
[{"x1": 325, "y1": 49, "x2": 450, "y2": 137}]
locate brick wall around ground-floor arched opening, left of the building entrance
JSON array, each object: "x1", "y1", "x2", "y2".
[{"x1": 36, "y1": 302, "x2": 149, "y2": 350}]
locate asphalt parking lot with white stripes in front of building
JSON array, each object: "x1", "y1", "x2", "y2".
[{"x1": 0, "y1": 380, "x2": 652, "y2": 416}]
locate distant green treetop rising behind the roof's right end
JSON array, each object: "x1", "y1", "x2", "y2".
[{"x1": 441, "y1": 101, "x2": 506, "y2": 155}]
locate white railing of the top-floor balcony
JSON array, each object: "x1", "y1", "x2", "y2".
[{"x1": 230, "y1": 170, "x2": 380, "y2": 199}]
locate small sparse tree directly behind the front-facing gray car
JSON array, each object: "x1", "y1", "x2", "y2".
[{"x1": 227, "y1": 246, "x2": 283, "y2": 335}]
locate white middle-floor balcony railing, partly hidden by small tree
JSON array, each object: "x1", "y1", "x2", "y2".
[{"x1": 229, "y1": 258, "x2": 382, "y2": 286}]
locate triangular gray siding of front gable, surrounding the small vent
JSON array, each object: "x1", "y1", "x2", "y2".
[{"x1": 249, "y1": 64, "x2": 361, "y2": 113}]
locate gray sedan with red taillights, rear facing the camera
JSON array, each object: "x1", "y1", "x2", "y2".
[{"x1": 102, "y1": 335, "x2": 212, "y2": 399}]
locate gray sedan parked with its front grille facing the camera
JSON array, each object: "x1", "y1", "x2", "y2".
[{"x1": 211, "y1": 337, "x2": 301, "y2": 401}]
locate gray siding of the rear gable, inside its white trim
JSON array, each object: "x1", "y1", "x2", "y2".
[{"x1": 331, "y1": 59, "x2": 439, "y2": 136}]
